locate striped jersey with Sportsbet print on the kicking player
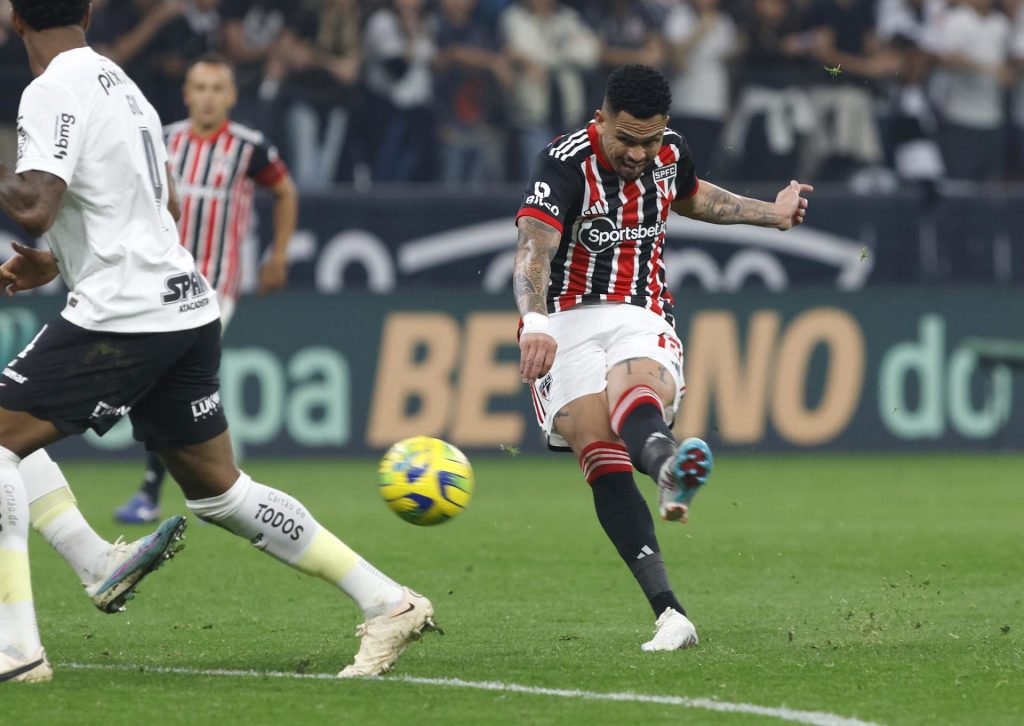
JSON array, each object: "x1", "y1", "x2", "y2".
[{"x1": 516, "y1": 122, "x2": 699, "y2": 323}]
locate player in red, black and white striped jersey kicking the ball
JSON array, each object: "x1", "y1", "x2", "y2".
[{"x1": 513, "y1": 66, "x2": 813, "y2": 650}]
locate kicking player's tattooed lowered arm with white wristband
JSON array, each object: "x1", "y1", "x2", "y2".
[{"x1": 512, "y1": 217, "x2": 561, "y2": 383}]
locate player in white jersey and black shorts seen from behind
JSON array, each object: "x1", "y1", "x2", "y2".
[{"x1": 0, "y1": 0, "x2": 433, "y2": 682}]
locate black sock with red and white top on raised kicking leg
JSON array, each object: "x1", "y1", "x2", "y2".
[{"x1": 611, "y1": 386, "x2": 676, "y2": 481}]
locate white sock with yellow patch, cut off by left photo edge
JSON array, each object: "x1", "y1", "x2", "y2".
[{"x1": 0, "y1": 446, "x2": 43, "y2": 660}]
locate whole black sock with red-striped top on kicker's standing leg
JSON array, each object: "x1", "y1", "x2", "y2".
[{"x1": 580, "y1": 441, "x2": 686, "y2": 617}]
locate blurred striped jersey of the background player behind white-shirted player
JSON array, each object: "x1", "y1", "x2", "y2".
[{"x1": 164, "y1": 120, "x2": 288, "y2": 299}]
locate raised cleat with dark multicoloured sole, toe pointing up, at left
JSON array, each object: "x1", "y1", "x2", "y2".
[{"x1": 85, "y1": 516, "x2": 186, "y2": 612}]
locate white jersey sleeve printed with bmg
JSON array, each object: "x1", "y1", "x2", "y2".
[{"x1": 15, "y1": 79, "x2": 85, "y2": 186}]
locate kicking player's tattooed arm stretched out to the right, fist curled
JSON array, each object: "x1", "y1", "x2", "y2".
[{"x1": 672, "y1": 180, "x2": 814, "y2": 230}]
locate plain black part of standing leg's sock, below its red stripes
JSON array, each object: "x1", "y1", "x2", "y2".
[{"x1": 591, "y1": 471, "x2": 686, "y2": 617}]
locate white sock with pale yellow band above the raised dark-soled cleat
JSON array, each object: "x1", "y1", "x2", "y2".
[{"x1": 18, "y1": 449, "x2": 111, "y2": 585}]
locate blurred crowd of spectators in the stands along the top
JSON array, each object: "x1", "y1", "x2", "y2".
[{"x1": 0, "y1": 0, "x2": 1024, "y2": 189}]
